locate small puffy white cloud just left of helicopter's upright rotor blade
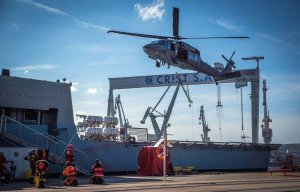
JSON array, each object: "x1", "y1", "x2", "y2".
[{"x1": 134, "y1": 0, "x2": 165, "y2": 21}]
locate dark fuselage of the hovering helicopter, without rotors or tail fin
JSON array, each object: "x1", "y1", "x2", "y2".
[{"x1": 143, "y1": 39, "x2": 223, "y2": 79}]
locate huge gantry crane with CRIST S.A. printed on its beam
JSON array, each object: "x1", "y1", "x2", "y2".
[{"x1": 107, "y1": 65, "x2": 259, "y2": 143}]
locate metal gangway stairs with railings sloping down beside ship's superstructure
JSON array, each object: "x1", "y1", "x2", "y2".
[{"x1": 0, "y1": 116, "x2": 89, "y2": 175}]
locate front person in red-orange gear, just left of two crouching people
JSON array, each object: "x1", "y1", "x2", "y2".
[{"x1": 35, "y1": 160, "x2": 48, "y2": 188}]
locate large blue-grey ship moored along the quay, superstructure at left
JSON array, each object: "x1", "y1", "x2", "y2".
[{"x1": 0, "y1": 67, "x2": 280, "y2": 174}]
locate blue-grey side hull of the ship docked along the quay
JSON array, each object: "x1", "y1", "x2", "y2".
[{"x1": 2, "y1": 123, "x2": 279, "y2": 173}]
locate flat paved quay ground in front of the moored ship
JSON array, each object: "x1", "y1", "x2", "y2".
[{"x1": 0, "y1": 172, "x2": 300, "y2": 192}]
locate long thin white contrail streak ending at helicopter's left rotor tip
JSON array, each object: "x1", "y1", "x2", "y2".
[{"x1": 18, "y1": 0, "x2": 109, "y2": 31}]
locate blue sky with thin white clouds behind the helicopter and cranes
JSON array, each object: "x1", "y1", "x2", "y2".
[{"x1": 0, "y1": 0, "x2": 300, "y2": 143}]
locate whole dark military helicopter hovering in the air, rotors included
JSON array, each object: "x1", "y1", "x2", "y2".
[{"x1": 107, "y1": 7, "x2": 249, "y2": 82}]
